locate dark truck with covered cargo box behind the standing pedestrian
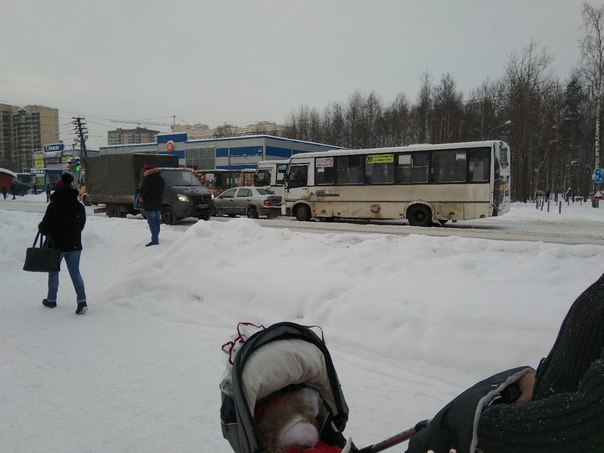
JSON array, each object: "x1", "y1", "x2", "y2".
[{"x1": 82, "y1": 154, "x2": 214, "y2": 224}]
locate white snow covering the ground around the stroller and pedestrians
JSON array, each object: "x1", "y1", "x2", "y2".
[{"x1": 0, "y1": 195, "x2": 604, "y2": 453}]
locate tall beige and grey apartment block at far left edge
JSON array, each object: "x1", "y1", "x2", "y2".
[{"x1": 0, "y1": 104, "x2": 59, "y2": 173}]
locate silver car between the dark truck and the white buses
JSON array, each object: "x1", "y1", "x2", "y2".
[{"x1": 214, "y1": 186, "x2": 281, "y2": 219}]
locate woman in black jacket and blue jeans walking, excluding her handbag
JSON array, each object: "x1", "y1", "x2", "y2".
[{"x1": 38, "y1": 173, "x2": 88, "y2": 315}]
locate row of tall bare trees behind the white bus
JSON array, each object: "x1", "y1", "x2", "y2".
[{"x1": 286, "y1": 3, "x2": 604, "y2": 201}]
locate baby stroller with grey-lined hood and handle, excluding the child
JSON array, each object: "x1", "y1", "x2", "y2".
[{"x1": 220, "y1": 322, "x2": 423, "y2": 453}]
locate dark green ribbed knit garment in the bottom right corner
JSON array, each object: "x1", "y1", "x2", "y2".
[{"x1": 478, "y1": 275, "x2": 604, "y2": 453}]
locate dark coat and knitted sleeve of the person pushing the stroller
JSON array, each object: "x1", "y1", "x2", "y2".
[{"x1": 407, "y1": 275, "x2": 604, "y2": 453}]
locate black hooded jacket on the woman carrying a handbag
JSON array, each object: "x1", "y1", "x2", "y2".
[{"x1": 38, "y1": 187, "x2": 86, "y2": 252}]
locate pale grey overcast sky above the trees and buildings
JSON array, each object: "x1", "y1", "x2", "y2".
[{"x1": 0, "y1": 0, "x2": 604, "y2": 148}]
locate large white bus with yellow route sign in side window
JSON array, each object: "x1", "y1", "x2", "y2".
[{"x1": 282, "y1": 141, "x2": 510, "y2": 226}]
